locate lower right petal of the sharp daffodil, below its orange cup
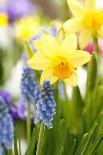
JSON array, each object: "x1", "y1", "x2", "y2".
[{"x1": 64, "y1": 71, "x2": 78, "y2": 86}]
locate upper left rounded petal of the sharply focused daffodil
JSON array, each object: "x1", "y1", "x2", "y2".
[{"x1": 34, "y1": 34, "x2": 59, "y2": 58}]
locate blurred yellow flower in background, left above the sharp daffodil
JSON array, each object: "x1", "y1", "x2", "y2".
[{"x1": 15, "y1": 16, "x2": 40, "y2": 41}]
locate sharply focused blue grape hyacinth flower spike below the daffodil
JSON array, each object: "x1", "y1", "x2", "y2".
[{"x1": 35, "y1": 81, "x2": 56, "y2": 128}]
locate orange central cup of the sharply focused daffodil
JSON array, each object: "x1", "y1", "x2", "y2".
[{"x1": 53, "y1": 62, "x2": 73, "y2": 80}]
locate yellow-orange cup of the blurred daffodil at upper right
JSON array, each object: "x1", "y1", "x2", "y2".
[{"x1": 84, "y1": 12, "x2": 103, "y2": 31}]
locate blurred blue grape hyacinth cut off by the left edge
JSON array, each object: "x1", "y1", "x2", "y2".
[{"x1": 0, "y1": 97, "x2": 13, "y2": 155}]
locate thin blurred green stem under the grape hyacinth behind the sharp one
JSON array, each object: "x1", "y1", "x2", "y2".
[{"x1": 27, "y1": 104, "x2": 31, "y2": 145}]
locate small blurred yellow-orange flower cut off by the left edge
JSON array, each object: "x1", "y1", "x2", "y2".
[{"x1": 0, "y1": 13, "x2": 8, "y2": 27}]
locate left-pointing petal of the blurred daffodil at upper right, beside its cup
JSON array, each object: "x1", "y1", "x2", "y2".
[{"x1": 63, "y1": 17, "x2": 83, "y2": 33}]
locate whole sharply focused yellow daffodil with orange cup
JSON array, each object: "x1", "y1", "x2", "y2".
[{"x1": 28, "y1": 31, "x2": 91, "y2": 86}]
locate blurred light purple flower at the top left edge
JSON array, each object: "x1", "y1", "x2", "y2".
[{"x1": 0, "y1": 0, "x2": 34, "y2": 22}]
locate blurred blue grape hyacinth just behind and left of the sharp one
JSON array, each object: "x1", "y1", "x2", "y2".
[{"x1": 21, "y1": 66, "x2": 40, "y2": 104}]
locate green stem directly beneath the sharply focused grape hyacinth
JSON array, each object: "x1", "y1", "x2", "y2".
[{"x1": 36, "y1": 123, "x2": 45, "y2": 155}]
